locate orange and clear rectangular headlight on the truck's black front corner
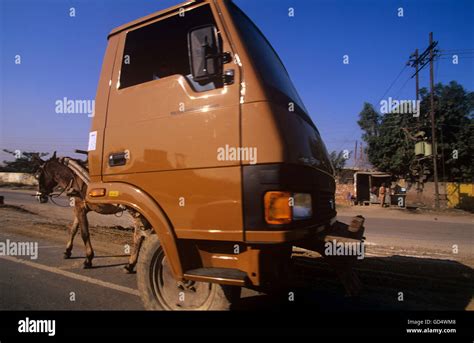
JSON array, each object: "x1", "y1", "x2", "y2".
[{"x1": 264, "y1": 191, "x2": 313, "y2": 224}]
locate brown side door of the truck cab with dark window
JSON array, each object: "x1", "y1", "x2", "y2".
[{"x1": 102, "y1": 3, "x2": 242, "y2": 239}]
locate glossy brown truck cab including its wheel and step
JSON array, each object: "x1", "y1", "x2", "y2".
[{"x1": 87, "y1": 0, "x2": 360, "y2": 309}]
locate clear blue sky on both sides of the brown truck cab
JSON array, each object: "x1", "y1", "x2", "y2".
[{"x1": 0, "y1": 0, "x2": 474, "y2": 165}]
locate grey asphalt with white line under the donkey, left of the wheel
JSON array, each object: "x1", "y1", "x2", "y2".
[{"x1": 0, "y1": 228, "x2": 143, "y2": 310}]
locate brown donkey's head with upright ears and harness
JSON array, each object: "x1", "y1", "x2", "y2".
[{"x1": 33, "y1": 151, "x2": 73, "y2": 203}]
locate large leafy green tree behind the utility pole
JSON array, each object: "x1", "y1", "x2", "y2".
[{"x1": 358, "y1": 81, "x2": 474, "y2": 182}]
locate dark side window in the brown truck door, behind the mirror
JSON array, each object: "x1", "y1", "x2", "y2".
[{"x1": 120, "y1": 5, "x2": 217, "y2": 92}]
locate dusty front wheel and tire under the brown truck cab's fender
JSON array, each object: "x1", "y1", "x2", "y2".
[{"x1": 137, "y1": 234, "x2": 241, "y2": 311}]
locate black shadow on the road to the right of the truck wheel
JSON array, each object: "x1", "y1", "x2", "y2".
[{"x1": 235, "y1": 255, "x2": 474, "y2": 311}]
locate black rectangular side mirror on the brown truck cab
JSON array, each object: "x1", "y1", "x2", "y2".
[{"x1": 188, "y1": 25, "x2": 222, "y2": 82}]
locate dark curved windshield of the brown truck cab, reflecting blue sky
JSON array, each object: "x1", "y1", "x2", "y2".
[{"x1": 229, "y1": 2, "x2": 307, "y2": 114}]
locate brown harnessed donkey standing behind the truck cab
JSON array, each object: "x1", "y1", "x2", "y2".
[{"x1": 34, "y1": 152, "x2": 151, "y2": 273}]
